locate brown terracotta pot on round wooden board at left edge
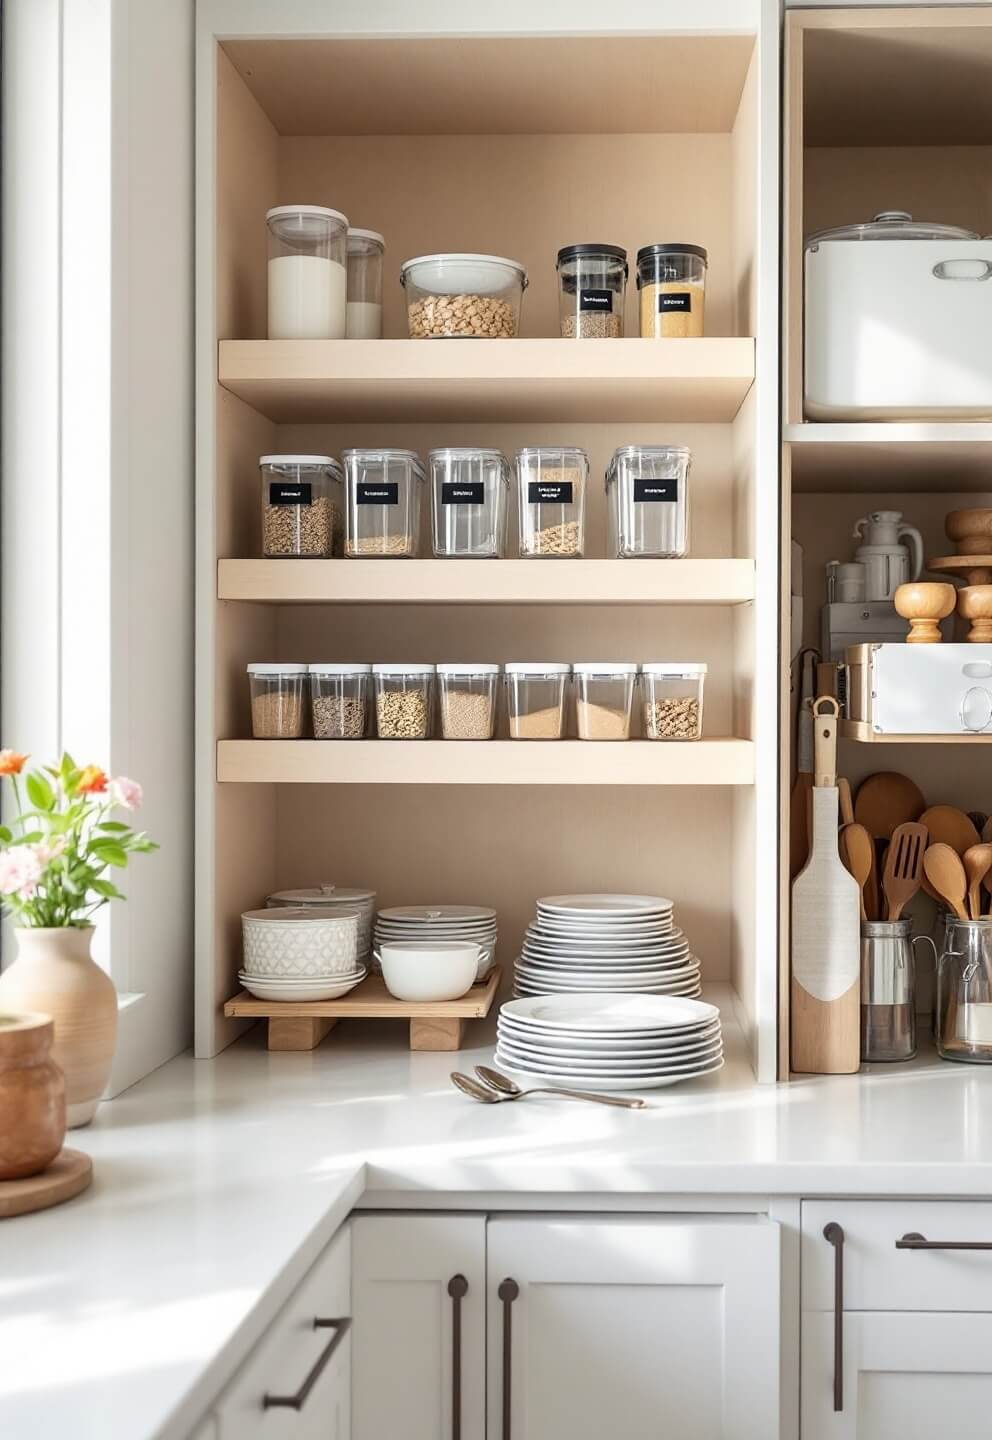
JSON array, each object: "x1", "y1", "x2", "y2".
[{"x1": 0, "y1": 1014, "x2": 65, "y2": 1181}]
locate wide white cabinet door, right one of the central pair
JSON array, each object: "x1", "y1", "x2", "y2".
[{"x1": 488, "y1": 1217, "x2": 779, "y2": 1440}]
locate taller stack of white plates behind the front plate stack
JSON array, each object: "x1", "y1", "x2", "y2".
[{"x1": 514, "y1": 894, "x2": 700, "y2": 996}]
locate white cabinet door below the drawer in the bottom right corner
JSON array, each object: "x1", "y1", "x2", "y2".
[{"x1": 802, "y1": 1310, "x2": 992, "y2": 1440}]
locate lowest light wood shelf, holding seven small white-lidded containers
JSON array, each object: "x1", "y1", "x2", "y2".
[{"x1": 217, "y1": 739, "x2": 754, "y2": 786}]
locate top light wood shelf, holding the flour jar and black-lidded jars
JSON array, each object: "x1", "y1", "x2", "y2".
[{"x1": 219, "y1": 338, "x2": 754, "y2": 423}]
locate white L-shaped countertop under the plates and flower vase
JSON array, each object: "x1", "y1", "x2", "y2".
[{"x1": 0, "y1": 996, "x2": 992, "y2": 1440}]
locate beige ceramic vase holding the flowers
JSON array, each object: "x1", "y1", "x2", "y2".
[{"x1": 0, "y1": 926, "x2": 117, "y2": 1129}]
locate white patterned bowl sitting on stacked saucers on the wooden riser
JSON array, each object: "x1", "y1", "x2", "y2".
[{"x1": 238, "y1": 906, "x2": 369, "y2": 1001}]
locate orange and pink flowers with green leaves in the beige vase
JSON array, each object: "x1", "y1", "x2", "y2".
[{"x1": 0, "y1": 750, "x2": 158, "y2": 929}]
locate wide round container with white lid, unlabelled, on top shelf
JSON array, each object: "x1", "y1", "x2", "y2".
[{"x1": 400, "y1": 253, "x2": 527, "y2": 340}]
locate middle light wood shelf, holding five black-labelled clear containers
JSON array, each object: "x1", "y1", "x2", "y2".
[{"x1": 217, "y1": 560, "x2": 754, "y2": 605}]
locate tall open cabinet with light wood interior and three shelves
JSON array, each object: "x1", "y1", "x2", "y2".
[{"x1": 197, "y1": 4, "x2": 777, "y2": 1079}]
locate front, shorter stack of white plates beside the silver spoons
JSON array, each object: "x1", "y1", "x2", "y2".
[{"x1": 495, "y1": 994, "x2": 723, "y2": 1090}]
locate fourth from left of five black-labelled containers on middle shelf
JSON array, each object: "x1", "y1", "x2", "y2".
[{"x1": 517, "y1": 445, "x2": 589, "y2": 560}]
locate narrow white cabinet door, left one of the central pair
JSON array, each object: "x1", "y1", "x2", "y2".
[{"x1": 351, "y1": 1215, "x2": 485, "y2": 1440}]
